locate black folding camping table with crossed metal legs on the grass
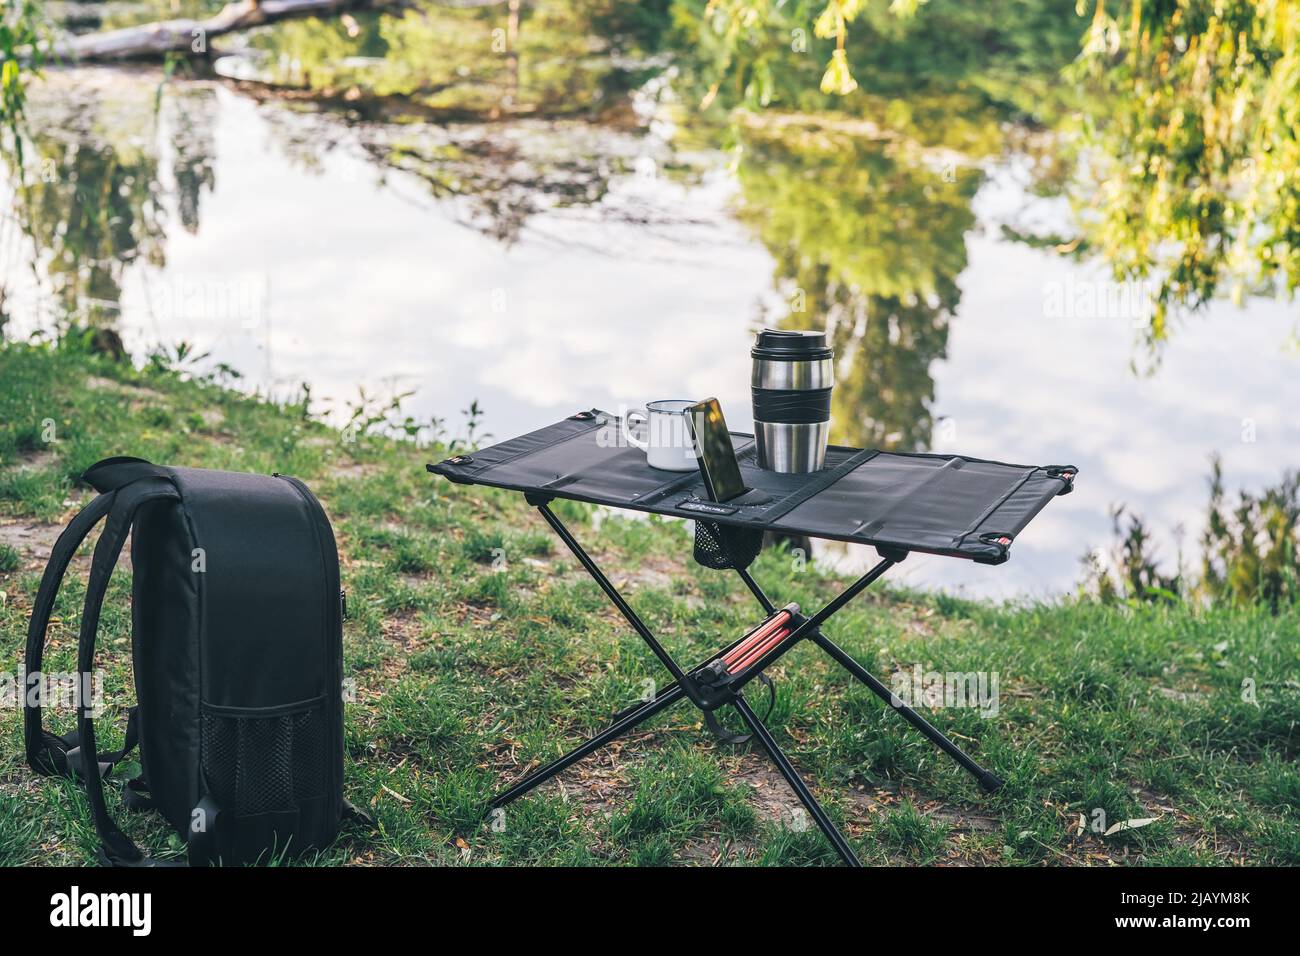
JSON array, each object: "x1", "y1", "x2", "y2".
[{"x1": 428, "y1": 408, "x2": 1078, "y2": 865}]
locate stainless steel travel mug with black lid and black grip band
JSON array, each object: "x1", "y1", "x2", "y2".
[{"x1": 750, "y1": 329, "x2": 835, "y2": 475}]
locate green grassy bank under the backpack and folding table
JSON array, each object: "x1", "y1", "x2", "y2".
[{"x1": 0, "y1": 346, "x2": 1300, "y2": 865}]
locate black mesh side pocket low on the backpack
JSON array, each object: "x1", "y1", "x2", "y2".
[{"x1": 202, "y1": 705, "x2": 328, "y2": 816}]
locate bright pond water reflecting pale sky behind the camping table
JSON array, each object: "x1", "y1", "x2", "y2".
[{"x1": 0, "y1": 69, "x2": 1300, "y2": 597}]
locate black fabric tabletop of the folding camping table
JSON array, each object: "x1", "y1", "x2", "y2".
[{"x1": 428, "y1": 408, "x2": 1078, "y2": 564}]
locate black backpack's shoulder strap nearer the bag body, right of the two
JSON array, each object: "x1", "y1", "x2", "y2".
[{"x1": 77, "y1": 477, "x2": 181, "y2": 866}]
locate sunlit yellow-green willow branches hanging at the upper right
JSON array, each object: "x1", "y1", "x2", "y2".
[{"x1": 1073, "y1": 0, "x2": 1300, "y2": 342}]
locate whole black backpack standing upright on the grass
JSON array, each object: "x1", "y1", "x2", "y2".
[{"x1": 23, "y1": 458, "x2": 355, "y2": 866}]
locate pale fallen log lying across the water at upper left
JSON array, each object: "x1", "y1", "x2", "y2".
[{"x1": 35, "y1": 0, "x2": 411, "y2": 62}]
